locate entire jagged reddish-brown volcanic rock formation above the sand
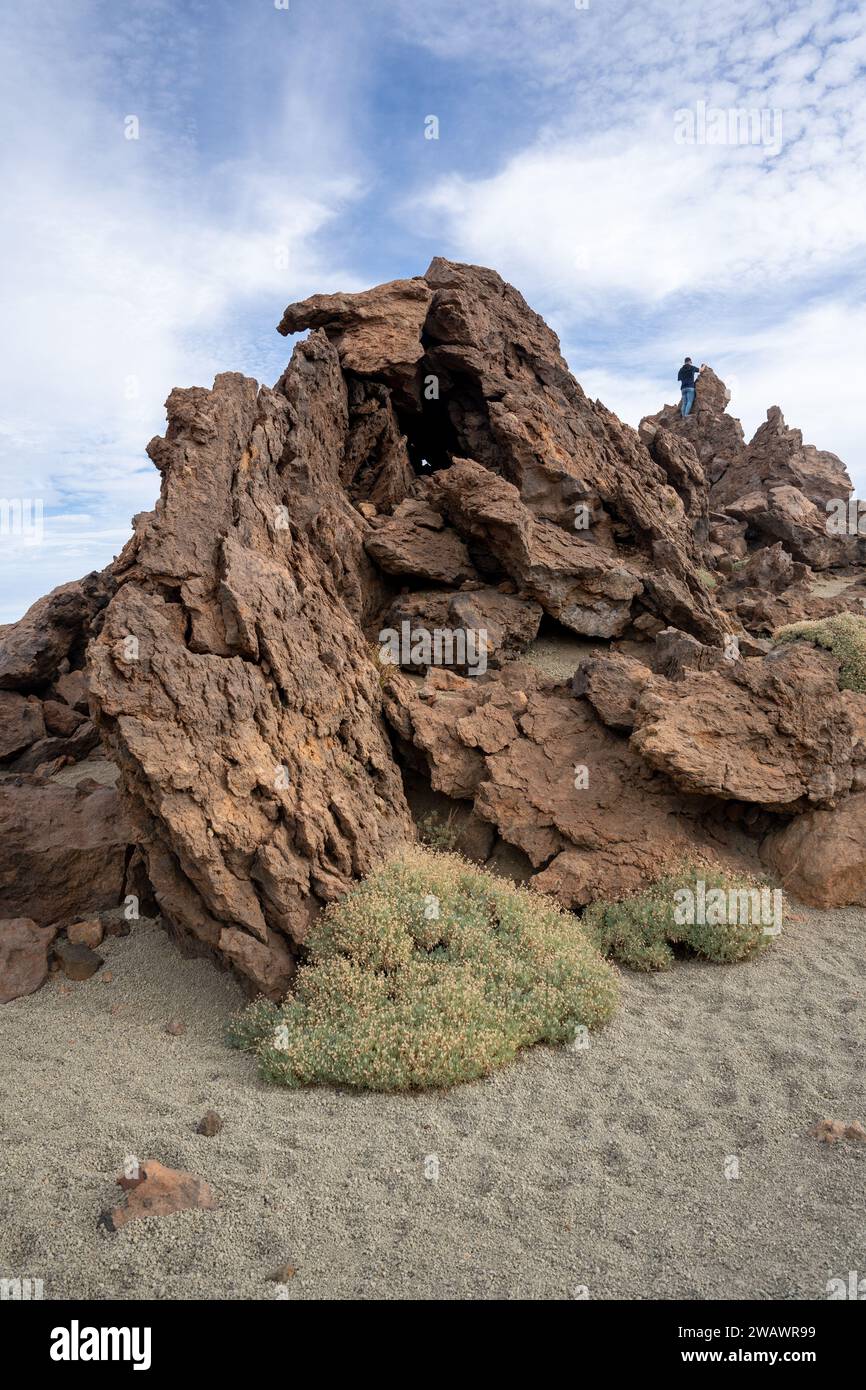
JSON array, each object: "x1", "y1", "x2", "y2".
[{"x1": 0, "y1": 259, "x2": 866, "y2": 998}]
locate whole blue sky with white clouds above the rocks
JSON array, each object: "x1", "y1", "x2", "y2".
[{"x1": 0, "y1": 0, "x2": 866, "y2": 623}]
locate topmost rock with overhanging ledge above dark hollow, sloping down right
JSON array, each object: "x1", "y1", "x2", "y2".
[{"x1": 281, "y1": 257, "x2": 734, "y2": 642}]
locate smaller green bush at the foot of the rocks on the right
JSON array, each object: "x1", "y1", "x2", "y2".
[{"x1": 581, "y1": 865, "x2": 784, "y2": 970}]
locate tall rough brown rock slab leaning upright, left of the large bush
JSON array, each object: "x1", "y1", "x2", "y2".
[{"x1": 90, "y1": 334, "x2": 411, "y2": 997}]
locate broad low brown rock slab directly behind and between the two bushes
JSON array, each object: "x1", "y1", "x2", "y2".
[{"x1": 385, "y1": 663, "x2": 756, "y2": 906}]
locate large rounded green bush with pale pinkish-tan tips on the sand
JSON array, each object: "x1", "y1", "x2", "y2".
[{"x1": 229, "y1": 845, "x2": 619, "y2": 1091}]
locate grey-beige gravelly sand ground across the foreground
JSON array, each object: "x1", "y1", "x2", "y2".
[{"x1": 0, "y1": 909, "x2": 866, "y2": 1300}]
